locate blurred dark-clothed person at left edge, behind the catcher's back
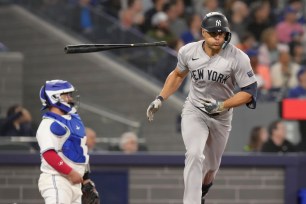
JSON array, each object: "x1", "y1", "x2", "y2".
[{"x1": 0, "y1": 105, "x2": 35, "y2": 136}]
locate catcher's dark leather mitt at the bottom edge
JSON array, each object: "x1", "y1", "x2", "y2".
[{"x1": 82, "y1": 180, "x2": 100, "y2": 204}]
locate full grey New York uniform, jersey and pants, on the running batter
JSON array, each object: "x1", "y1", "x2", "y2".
[{"x1": 177, "y1": 40, "x2": 256, "y2": 204}]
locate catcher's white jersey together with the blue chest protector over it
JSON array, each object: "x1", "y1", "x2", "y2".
[{"x1": 36, "y1": 112, "x2": 89, "y2": 175}]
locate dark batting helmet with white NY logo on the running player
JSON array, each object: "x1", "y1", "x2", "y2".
[{"x1": 201, "y1": 12, "x2": 231, "y2": 49}]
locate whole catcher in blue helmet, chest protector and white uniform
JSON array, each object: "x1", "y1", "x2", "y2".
[{"x1": 36, "y1": 80, "x2": 99, "y2": 204}]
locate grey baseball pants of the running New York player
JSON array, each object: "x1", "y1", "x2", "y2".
[{"x1": 182, "y1": 102, "x2": 232, "y2": 204}]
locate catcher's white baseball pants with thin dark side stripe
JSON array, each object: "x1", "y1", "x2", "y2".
[{"x1": 38, "y1": 173, "x2": 82, "y2": 204}]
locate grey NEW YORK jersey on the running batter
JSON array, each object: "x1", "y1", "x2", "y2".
[{"x1": 177, "y1": 40, "x2": 256, "y2": 107}]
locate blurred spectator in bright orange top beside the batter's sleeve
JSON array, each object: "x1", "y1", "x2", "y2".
[{"x1": 246, "y1": 49, "x2": 271, "y2": 91}]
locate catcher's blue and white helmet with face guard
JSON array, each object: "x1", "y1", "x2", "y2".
[{"x1": 39, "y1": 80, "x2": 77, "y2": 113}]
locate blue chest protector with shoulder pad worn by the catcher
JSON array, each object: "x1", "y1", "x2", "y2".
[{"x1": 44, "y1": 112, "x2": 86, "y2": 163}]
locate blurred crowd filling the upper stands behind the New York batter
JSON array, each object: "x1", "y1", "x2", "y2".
[{"x1": 95, "y1": 0, "x2": 306, "y2": 101}]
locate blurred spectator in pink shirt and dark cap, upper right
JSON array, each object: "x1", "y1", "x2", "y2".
[{"x1": 276, "y1": 7, "x2": 304, "y2": 44}]
